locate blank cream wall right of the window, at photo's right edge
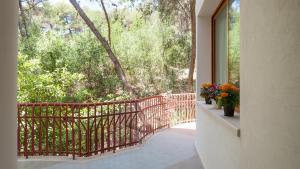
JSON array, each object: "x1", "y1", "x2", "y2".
[{"x1": 241, "y1": 0, "x2": 300, "y2": 169}]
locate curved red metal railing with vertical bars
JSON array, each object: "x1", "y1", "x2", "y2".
[{"x1": 17, "y1": 93, "x2": 195, "y2": 158}]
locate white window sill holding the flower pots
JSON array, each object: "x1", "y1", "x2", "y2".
[{"x1": 196, "y1": 101, "x2": 241, "y2": 137}]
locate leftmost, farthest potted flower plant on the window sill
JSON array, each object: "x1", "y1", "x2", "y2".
[{"x1": 200, "y1": 83, "x2": 218, "y2": 104}]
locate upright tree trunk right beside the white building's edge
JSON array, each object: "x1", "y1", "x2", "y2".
[{"x1": 188, "y1": 0, "x2": 196, "y2": 92}]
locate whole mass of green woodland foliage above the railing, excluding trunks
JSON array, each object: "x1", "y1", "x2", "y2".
[{"x1": 18, "y1": 2, "x2": 191, "y2": 102}]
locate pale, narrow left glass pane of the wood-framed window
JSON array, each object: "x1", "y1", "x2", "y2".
[{"x1": 215, "y1": 7, "x2": 228, "y2": 84}]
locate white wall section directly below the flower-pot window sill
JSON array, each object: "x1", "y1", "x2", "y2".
[{"x1": 195, "y1": 104, "x2": 241, "y2": 169}]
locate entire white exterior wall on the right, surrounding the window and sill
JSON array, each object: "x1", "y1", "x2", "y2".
[{"x1": 196, "y1": 0, "x2": 300, "y2": 169}]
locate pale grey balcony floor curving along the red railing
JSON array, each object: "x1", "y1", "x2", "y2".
[{"x1": 18, "y1": 123, "x2": 204, "y2": 169}]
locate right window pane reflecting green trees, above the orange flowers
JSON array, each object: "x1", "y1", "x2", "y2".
[{"x1": 228, "y1": 0, "x2": 240, "y2": 83}]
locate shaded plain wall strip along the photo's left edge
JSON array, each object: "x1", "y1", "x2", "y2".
[{"x1": 0, "y1": 0, "x2": 18, "y2": 169}]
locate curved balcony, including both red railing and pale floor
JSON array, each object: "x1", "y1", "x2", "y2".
[{"x1": 18, "y1": 94, "x2": 202, "y2": 169}]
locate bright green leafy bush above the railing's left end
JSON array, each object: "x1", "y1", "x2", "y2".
[{"x1": 18, "y1": 54, "x2": 88, "y2": 102}]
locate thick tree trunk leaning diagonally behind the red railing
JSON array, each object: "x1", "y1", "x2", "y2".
[{"x1": 69, "y1": 0, "x2": 138, "y2": 96}]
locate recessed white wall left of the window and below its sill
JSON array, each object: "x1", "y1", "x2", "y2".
[{"x1": 195, "y1": 0, "x2": 240, "y2": 169}]
